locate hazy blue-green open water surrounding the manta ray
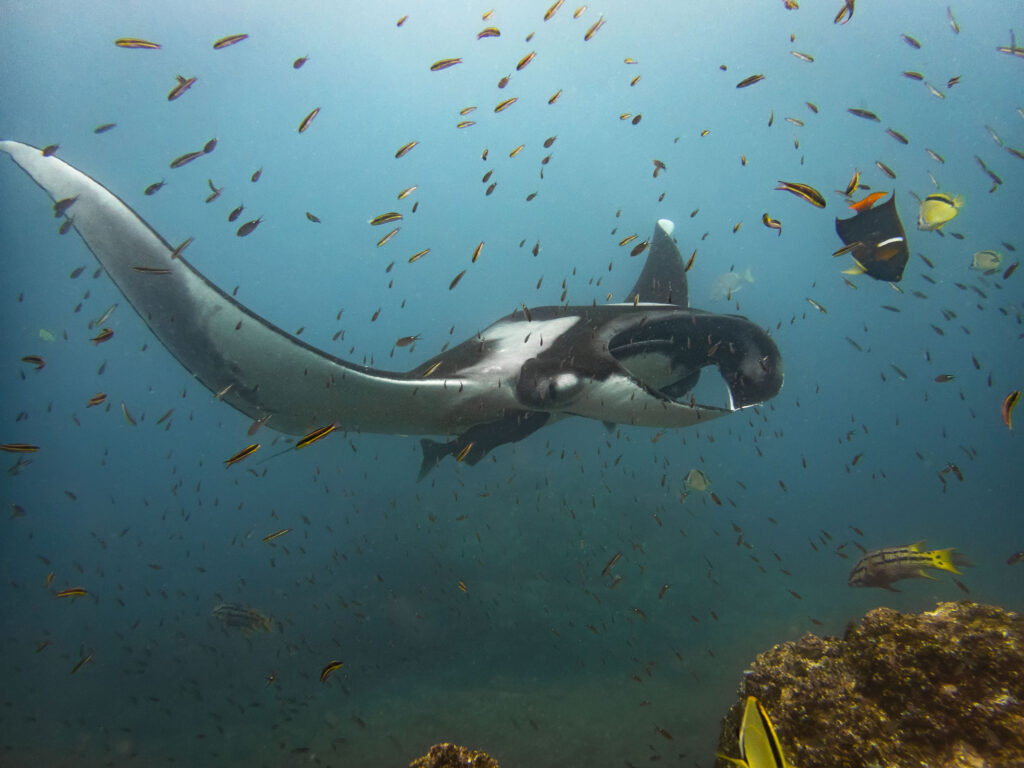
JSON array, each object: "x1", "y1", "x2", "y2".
[{"x1": 0, "y1": 0, "x2": 1024, "y2": 768}]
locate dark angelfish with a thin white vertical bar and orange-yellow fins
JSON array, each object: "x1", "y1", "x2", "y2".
[{"x1": 836, "y1": 193, "x2": 910, "y2": 283}]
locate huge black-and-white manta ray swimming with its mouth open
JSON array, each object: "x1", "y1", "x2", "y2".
[{"x1": 0, "y1": 141, "x2": 782, "y2": 477}]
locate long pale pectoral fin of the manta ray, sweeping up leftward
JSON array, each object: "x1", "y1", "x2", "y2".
[{"x1": 0, "y1": 141, "x2": 492, "y2": 434}]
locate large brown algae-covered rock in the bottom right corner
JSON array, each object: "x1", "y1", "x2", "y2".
[{"x1": 718, "y1": 601, "x2": 1024, "y2": 768}]
